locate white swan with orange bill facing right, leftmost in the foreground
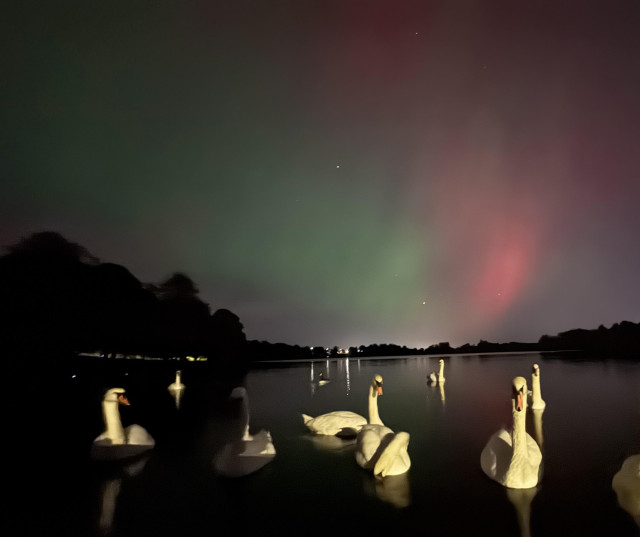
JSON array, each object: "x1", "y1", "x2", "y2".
[{"x1": 91, "y1": 388, "x2": 155, "y2": 461}]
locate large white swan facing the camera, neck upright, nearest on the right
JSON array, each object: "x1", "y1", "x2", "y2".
[{"x1": 480, "y1": 377, "x2": 542, "y2": 489}]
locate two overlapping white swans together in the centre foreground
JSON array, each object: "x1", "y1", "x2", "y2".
[{"x1": 302, "y1": 375, "x2": 411, "y2": 477}]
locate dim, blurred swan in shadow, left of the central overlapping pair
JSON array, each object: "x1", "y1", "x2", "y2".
[{"x1": 213, "y1": 386, "x2": 276, "y2": 477}]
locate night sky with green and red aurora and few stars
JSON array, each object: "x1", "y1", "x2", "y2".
[{"x1": 0, "y1": 0, "x2": 640, "y2": 347}]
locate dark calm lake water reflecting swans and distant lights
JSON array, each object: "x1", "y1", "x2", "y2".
[{"x1": 13, "y1": 353, "x2": 640, "y2": 537}]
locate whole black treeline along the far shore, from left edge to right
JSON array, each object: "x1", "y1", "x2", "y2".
[{"x1": 0, "y1": 232, "x2": 640, "y2": 371}]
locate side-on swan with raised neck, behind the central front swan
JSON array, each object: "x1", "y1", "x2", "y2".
[{"x1": 302, "y1": 375, "x2": 382, "y2": 437}]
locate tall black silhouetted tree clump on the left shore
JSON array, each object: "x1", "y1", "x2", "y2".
[{"x1": 0, "y1": 232, "x2": 248, "y2": 369}]
